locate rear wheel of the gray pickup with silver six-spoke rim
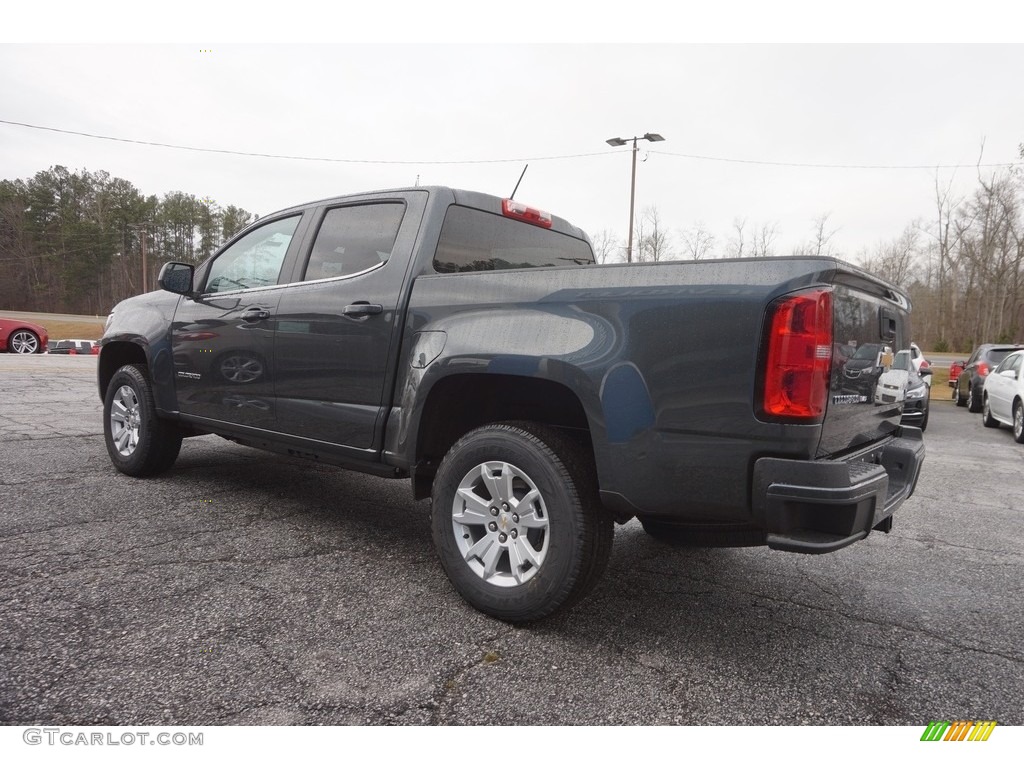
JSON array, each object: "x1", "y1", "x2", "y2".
[{"x1": 431, "y1": 423, "x2": 614, "y2": 623}]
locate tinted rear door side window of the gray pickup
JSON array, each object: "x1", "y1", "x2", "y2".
[{"x1": 302, "y1": 203, "x2": 406, "y2": 281}]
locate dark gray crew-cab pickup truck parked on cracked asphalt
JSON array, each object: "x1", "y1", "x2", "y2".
[{"x1": 98, "y1": 187, "x2": 925, "y2": 622}]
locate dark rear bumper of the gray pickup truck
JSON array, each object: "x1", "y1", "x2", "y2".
[{"x1": 753, "y1": 426, "x2": 925, "y2": 554}]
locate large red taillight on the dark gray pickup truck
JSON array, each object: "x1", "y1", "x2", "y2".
[{"x1": 763, "y1": 289, "x2": 833, "y2": 419}]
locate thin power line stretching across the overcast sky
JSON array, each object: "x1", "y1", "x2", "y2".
[{"x1": 0, "y1": 120, "x2": 1024, "y2": 171}]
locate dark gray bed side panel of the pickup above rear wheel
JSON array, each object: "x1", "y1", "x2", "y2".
[{"x1": 389, "y1": 259, "x2": 888, "y2": 522}]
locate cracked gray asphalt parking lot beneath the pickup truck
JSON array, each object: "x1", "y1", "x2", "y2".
[{"x1": 0, "y1": 355, "x2": 1024, "y2": 727}]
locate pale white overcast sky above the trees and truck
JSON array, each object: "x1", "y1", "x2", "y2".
[{"x1": 0, "y1": 5, "x2": 1024, "y2": 258}]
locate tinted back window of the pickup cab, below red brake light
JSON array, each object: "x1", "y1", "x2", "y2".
[{"x1": 434, "y1": 206, "x2": 594, "y2": 272}]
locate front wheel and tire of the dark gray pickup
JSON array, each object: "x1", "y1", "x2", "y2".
[{"x1": 103, "y1": 365, "x2": 183, "y2": 477}]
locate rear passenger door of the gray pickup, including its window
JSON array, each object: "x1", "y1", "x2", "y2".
[{"x1": 274, "y1": 191, "x2": 427, "y2": 457}]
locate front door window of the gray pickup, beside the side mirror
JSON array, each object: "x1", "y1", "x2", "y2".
[{"x1": 206, "y1": 215, "x2": 302, "y2": 293}]
